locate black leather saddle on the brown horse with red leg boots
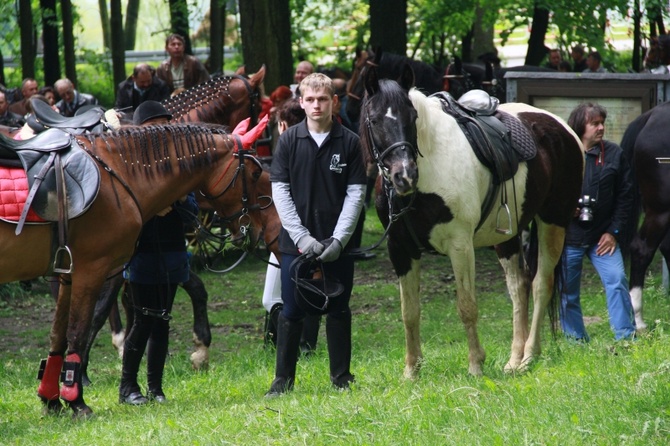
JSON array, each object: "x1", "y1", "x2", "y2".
[{"x1": 0, "y1": 129, "x2": 100, "y2": 234}]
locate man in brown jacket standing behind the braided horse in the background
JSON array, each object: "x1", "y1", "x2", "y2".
[{"x1": 156, "y1": 34, "x2": 209, "y2": 93}]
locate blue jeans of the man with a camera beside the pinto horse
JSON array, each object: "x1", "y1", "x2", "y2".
[{"x1": 561, "y1": 244, "x2": 635, "y2": 341}]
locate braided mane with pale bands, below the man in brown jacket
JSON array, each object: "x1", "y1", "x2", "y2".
[{"x1": 163, "y1": 75, "x2": 242, "y2": 121}]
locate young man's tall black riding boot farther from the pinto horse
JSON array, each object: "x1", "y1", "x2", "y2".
[{"x1": 265, "y1": 314, "x2": 302, "y2": 397}]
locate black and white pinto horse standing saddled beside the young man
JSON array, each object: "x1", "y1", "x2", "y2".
[{"x1": 360, "y1": 67, "x2": 583, "y2": 378}]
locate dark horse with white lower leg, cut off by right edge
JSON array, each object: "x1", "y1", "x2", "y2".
[{"x1": 621, "y1": 102, "x2": 670, "y2": 330}]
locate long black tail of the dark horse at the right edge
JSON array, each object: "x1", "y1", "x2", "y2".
[{"x1": 619, "y1": 109, "x2": 653, "y2": 260}]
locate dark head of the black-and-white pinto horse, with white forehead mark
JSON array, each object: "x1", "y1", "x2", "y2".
[{"x1": 360, "y1": 64, "x2": 419, "y2": 196}]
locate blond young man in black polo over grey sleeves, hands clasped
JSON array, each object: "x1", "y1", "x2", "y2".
[{"x1": 266, "y1": 73, "x2": 367, "y2": 397}]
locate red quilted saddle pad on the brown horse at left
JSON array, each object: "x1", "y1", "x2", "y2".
[{"x1": 0, "y1": 166, "x2": 46, "y2": 223}]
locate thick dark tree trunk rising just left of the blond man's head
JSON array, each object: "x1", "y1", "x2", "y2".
[{"x1": 239, "y1": 0, "x2": 293, "y2": 92}]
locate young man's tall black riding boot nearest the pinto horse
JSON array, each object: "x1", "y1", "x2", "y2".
[{"x1": 326, "y1": 311, "x2": 354, "y2": 389}]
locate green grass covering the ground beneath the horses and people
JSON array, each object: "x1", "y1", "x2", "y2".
[{"x1": 0, "y1": 207, "x2": 670, "y2": 445}]
